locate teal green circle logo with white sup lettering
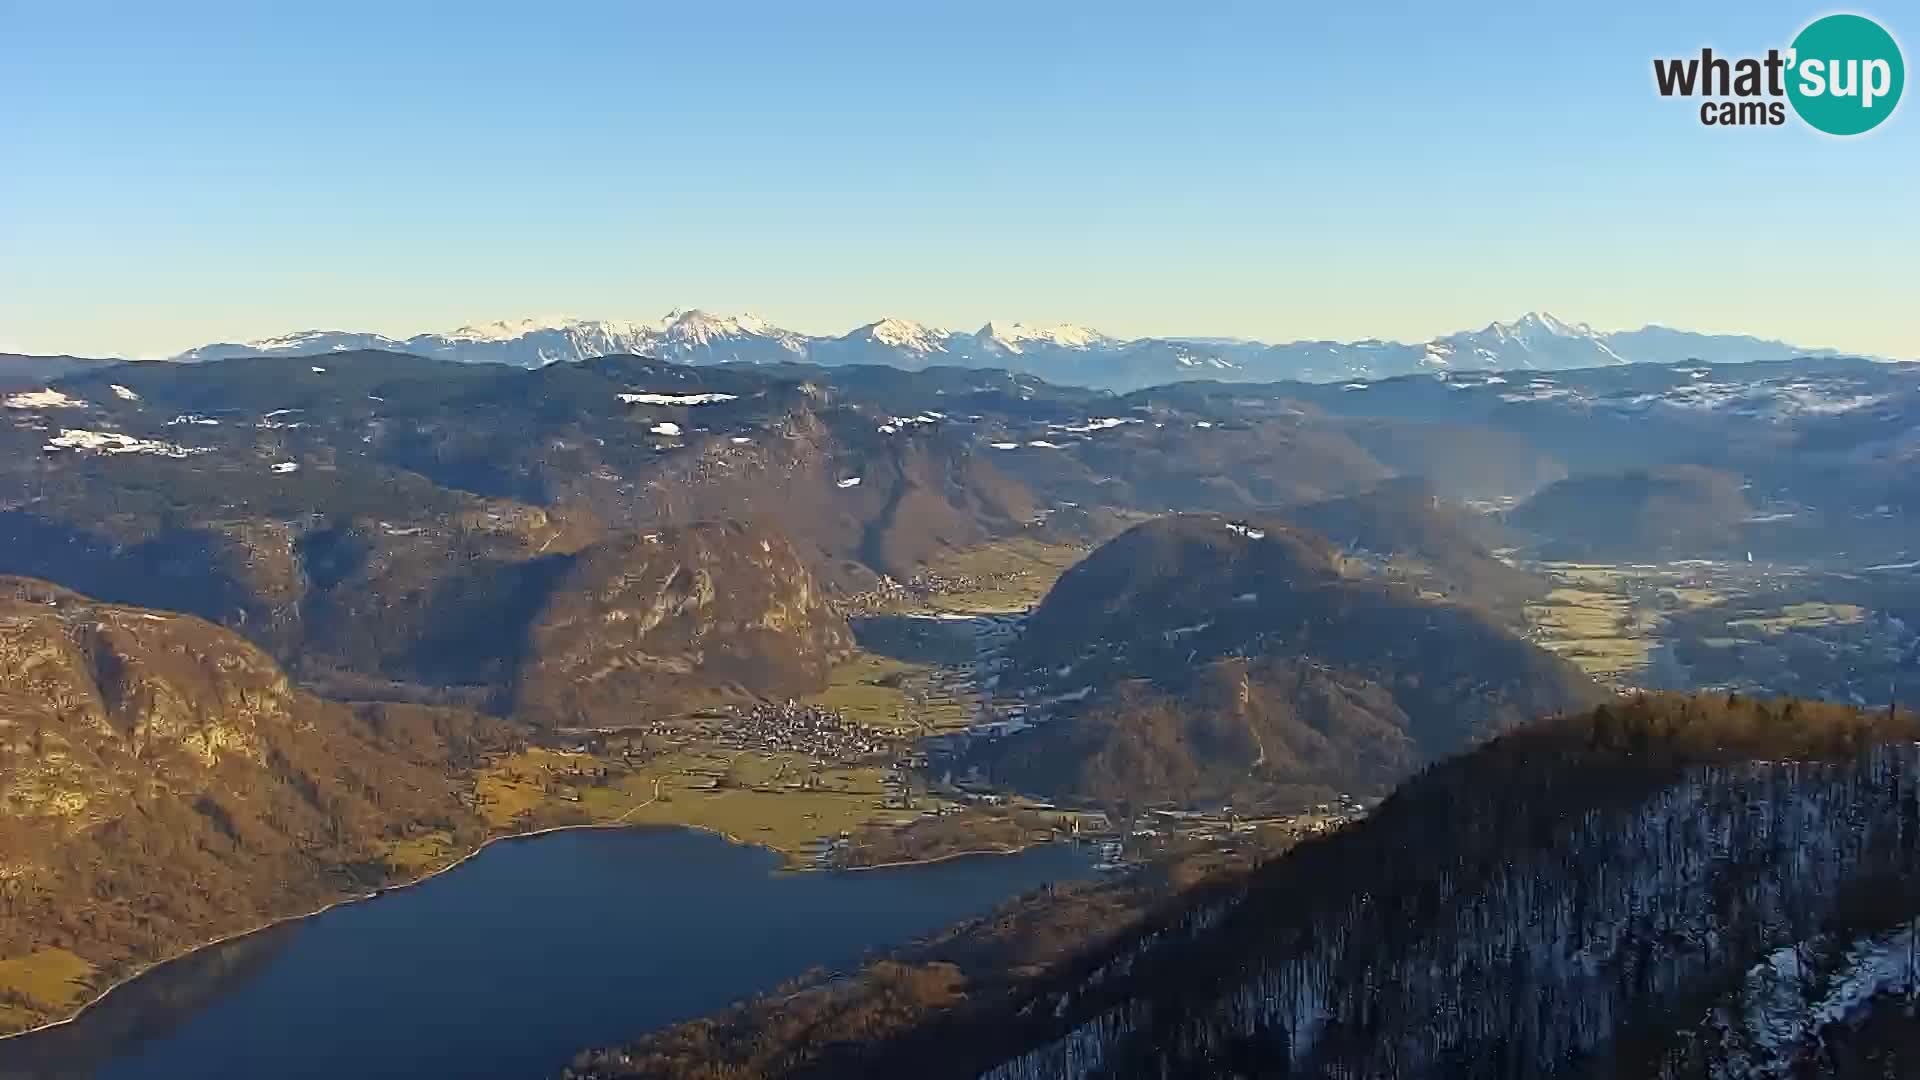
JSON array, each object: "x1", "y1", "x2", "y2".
[{"x1": 1788, "y1": 15, "x2": 1907, "y2": 135}]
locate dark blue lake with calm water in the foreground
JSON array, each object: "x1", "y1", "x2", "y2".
[{"x1": 0, "y1": 828, "x2": 1092, "y2": 1080}]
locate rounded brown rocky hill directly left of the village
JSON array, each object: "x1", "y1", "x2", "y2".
[{"x1": 516, "y1": 521, "x2": 852, "y2": 726}]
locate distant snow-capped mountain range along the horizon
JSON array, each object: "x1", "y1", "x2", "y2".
[{"x1": 175, "y1": 309, "x2": 1866, "y2": 390}]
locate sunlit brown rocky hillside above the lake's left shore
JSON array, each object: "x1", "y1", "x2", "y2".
[{"x1": 0, "y1": 578, "x2": 507, "y2": 1024}]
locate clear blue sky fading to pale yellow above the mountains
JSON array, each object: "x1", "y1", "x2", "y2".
[{"x1": 0, "y1": 0, "x2": 1920, "y2": 357}]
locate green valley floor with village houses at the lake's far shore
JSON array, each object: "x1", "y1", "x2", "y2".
[{"x1": 480, "y1": 541, "x2": 1373, "y2": 872}]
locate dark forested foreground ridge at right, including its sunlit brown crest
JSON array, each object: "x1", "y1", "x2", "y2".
[{"x1": 582, "y1": 696, "x2": 1920, "y2": 1080}]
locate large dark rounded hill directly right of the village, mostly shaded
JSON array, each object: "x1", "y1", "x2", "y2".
[{"x1": 967, "y1": 515, "x2": 1599, "y2": 807}]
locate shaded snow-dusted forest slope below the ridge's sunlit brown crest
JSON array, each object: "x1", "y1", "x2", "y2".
[{"x1": 985, "y1": 711, "x2": 1920, "y2": 1080}]
